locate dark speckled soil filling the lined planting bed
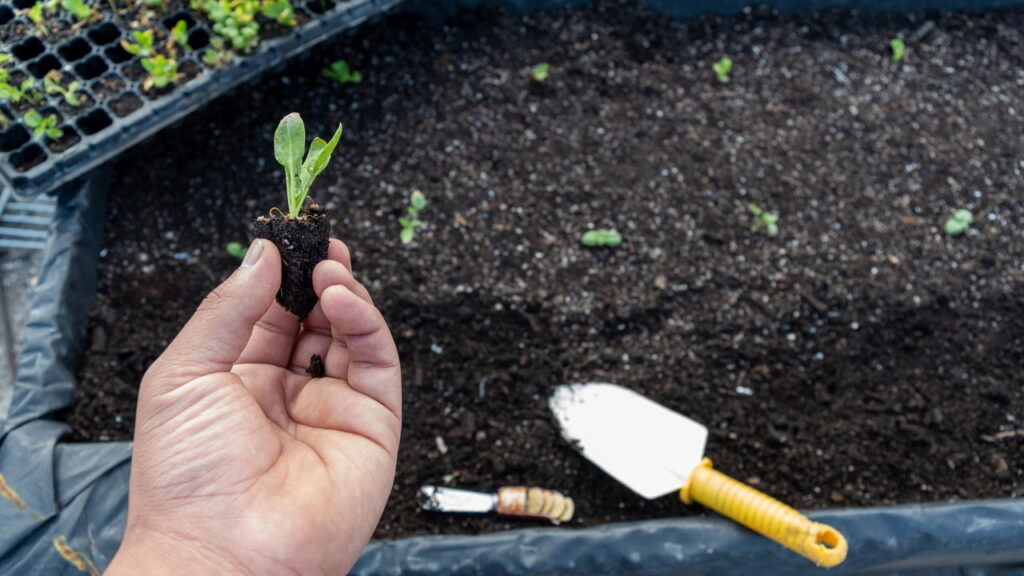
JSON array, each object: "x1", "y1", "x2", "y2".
[{"x1": 69, "y1": 2, "x2": 1024, "y2": 537}]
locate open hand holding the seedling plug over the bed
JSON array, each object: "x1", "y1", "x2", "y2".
[{"x1": 108, "y1": 240, "x2": 401, "y2": 575}]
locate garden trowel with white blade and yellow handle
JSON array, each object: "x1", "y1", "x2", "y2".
[{"x1": 549, "y1": 383, "x2": 847, "y2": 568}]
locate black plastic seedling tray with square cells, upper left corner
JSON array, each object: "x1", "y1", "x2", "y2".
[{"x1": 0, "y1": 0, "x2": 402, "y2": 196}]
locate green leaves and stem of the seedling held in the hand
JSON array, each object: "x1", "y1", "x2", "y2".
[{"x1": 273, "y1": 113, "x2": 341, "y2": 218}]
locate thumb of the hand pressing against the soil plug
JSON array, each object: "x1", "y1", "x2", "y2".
[{"x1": 147, "y1": 240, "x2": 281, "y2": 386}]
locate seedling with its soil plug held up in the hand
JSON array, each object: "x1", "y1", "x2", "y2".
[{"x1": 253, "y1": 113, "x2": 342, "y2": 319}]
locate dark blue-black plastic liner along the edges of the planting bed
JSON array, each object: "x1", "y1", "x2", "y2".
[{"x1": 0, "y1": 0, "x2": 1024, "y2": 576}]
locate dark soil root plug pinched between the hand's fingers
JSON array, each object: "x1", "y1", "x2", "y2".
[{"x1": 253, "y1": 203, "x2": 331, "y2": 319}]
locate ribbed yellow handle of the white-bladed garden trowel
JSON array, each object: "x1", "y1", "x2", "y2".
[{"x1": 679, "y1": 458, "x2": 846, "y2": 568}]
